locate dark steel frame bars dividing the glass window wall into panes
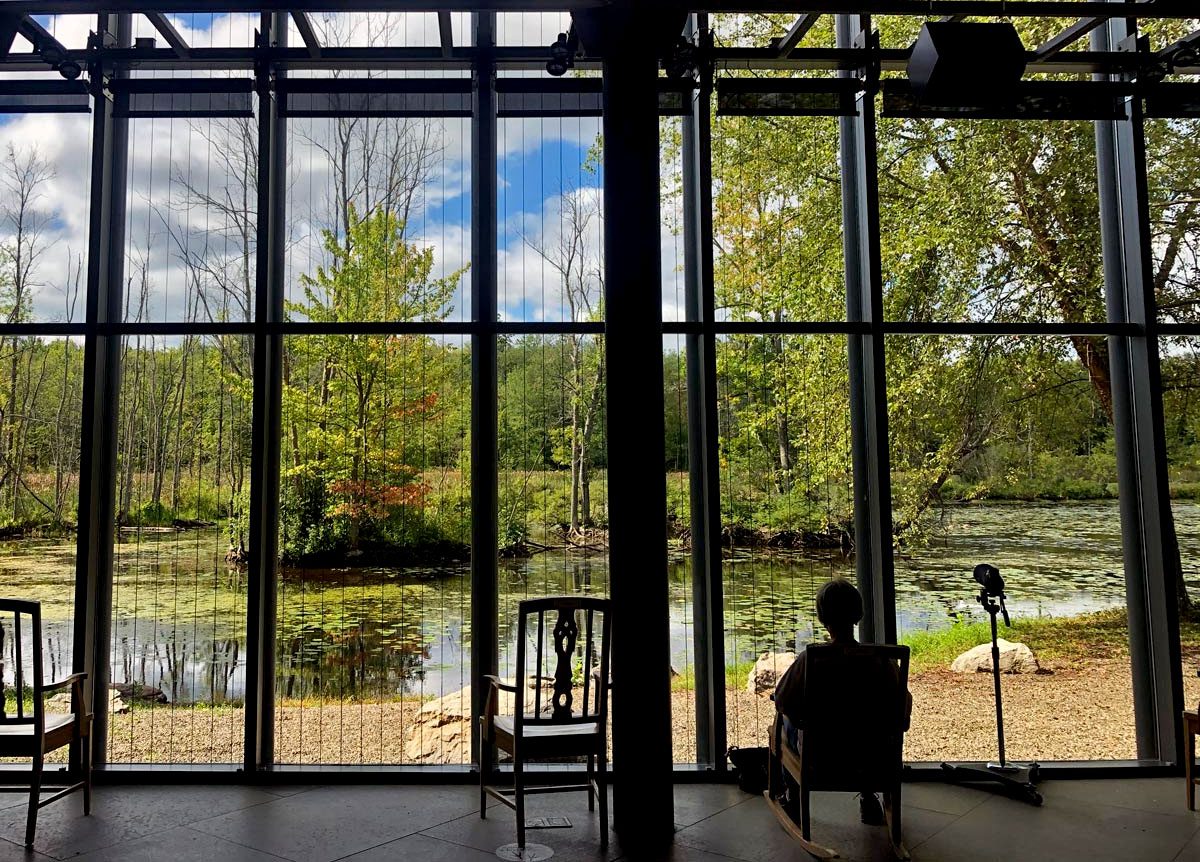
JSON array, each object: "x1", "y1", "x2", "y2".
[{"x1": 0, "y1": 0, "x2": 1176, "y2": 779}]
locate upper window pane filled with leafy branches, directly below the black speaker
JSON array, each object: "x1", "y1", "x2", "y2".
[{"x1": 878, "y1": 119, "x2": 1105, "y2": 322}]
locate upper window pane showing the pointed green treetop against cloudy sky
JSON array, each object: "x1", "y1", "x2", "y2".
[{"x1": 286, "y1": 116, "x2": 470, "y2": 324}]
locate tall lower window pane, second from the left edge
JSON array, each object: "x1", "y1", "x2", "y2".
[{"x1": 110, "y1": 336, "x2": 253, "y2": 764}]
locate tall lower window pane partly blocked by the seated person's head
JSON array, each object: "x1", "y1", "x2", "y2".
[{"x1": 716, "y1": 335, "x2": 854, "y2": 746}]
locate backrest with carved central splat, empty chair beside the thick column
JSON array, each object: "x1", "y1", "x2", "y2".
[{"x1": 516, "y1": 595, "x2": 612, "y2": 729}]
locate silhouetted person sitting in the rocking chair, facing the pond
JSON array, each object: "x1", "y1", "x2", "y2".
[{"x1": 774, "y1": 577, "x2": 912, "y2": 826}]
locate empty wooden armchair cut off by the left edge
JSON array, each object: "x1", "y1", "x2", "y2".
[{"x1": 0, "y1": 599, "x2": 91, "y2": 848}]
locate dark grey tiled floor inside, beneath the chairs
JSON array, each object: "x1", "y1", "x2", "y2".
[{"x1": 0, "y1": 779, "x2": 1200, "y2": 862}]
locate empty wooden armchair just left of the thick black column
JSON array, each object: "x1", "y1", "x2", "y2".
[{"x1": 479, "y1": 595, "x2": 611, "y2": 851}]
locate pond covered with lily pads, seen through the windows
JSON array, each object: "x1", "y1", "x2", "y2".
[{"x1": 0, "y1": 501, "x2": 1200, "y2": 704}]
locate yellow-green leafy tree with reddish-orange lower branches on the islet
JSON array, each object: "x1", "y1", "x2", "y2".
[{"x1": 284, "y1": 204, "x2": 464, "y2": 552}]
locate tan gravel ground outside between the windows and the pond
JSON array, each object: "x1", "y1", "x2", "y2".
[{"x1": 23, "y1": 654, "x2": 1200, "y2": 764}]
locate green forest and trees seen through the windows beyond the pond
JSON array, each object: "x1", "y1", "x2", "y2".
[{"x1": 0, "y1": 16, "x2": 1200, "y2": 600}]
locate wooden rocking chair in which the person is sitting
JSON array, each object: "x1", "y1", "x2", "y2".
[{"x1": 766, "y1": 643, "x2": 910, "y2": 860}]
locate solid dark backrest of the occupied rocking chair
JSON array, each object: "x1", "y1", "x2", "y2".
[{"x1": 800, "y1": 643, "x2": 908, "y2": 791}]
